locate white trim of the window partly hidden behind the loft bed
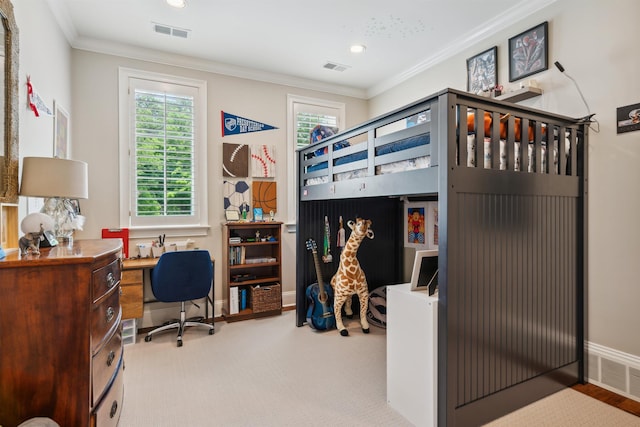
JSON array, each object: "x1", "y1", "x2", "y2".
[{"x1": 285, "y1": 94, "x2": 346, "y2": 233}]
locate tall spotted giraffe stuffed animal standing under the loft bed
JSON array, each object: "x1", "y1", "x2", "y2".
[{"x1": 331, "y1": 218, "x2": 373, "y2": 337}]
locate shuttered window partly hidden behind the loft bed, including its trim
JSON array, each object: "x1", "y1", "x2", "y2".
[{"x1": 287, "y1": 95, "x2": 345, "y2": 232}]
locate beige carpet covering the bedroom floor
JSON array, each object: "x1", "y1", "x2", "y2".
[{"x1": 119, "y1": 311, "x2": 640, "y2": 427}]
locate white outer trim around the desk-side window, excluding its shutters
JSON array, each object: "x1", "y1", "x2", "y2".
[{"x1": 118, "y1": 67, "x2": 210, "y2": 238}]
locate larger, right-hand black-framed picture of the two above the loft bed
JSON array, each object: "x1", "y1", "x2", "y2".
[{"x1": 509, "y1": 21, "x2": 549, "y2": 82}]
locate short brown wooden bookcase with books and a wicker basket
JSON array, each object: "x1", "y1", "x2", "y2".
[{"x1": 222, "y1": 221, "x2": 282, "y2": 322}]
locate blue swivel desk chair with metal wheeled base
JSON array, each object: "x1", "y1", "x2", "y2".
[{"x1": 144, "y1": 250, "x2": 214, "y2": 347}]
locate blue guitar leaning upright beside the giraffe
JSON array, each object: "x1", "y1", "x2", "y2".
[{"x1": 306, "y1": 239, "x2": 336, "y2": 331}]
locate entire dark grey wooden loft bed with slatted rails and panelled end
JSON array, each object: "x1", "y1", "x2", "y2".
[{"x1": 296, "y1": 89, "x2": 588, "y2": 426}]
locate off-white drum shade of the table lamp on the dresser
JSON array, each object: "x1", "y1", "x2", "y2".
[{"x1": 20, "y1": 157, "x2": 89, "y2": 199}]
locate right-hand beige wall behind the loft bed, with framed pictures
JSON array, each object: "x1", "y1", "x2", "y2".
[{"x1": 369, "y1": 0, "x2": 640, "y2": 356}]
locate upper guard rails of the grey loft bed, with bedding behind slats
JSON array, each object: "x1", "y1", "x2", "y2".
[{"x1": 298, "y1": 89, "x2": 581, "y2": 200}]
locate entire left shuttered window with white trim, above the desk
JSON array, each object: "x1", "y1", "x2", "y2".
[{"x1": 120, "y1": 69, "x2": 208, "y2": 237}]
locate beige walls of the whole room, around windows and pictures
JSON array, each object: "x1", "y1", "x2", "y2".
[{"x1": 14, "y1": 0, "x2": 640, "y2": 357}]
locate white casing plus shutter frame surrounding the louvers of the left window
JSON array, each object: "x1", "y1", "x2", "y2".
[{"x1": 119, "y1": 67, "x2": 210, "y2": 238}]
